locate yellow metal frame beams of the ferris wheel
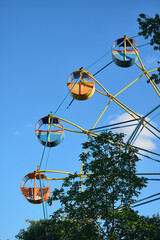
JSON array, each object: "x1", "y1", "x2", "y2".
[{"x1": 29, "y1": 35, "x2": 160, "y2": 218}]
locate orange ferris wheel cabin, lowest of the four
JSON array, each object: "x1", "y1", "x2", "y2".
[{"x1": 20, "y1": 168, "x2": 51, "y2": 204}]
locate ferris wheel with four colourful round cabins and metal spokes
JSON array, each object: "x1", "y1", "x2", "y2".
[{"x1": 20, "y1": 35, "x2": 160, "y2": 217}]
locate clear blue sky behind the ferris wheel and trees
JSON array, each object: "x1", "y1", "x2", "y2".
[{"x1": 0, "y1": 0, "x2": 160, "y2": 240}]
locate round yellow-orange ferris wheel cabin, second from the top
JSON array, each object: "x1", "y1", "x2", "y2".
[{"x1": 67, "y1": 69, "x2": 95, "y2": 100}]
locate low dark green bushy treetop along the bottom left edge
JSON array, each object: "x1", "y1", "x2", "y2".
[{"x1": 15, "y1": 218, "x2": 100, "y2": 240}]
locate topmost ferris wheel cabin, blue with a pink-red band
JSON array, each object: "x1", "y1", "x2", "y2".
[{"x1": 112, "y1": 36, "x2": 139, "y2": 67}]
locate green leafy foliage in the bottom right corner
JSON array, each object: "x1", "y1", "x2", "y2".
[{"x1": 107, "y1": 209, "x2": 160, "y2": 240}]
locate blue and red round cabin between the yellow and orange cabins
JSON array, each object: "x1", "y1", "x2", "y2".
[{"x1": 35, "y1": 115, "x2": 64, "y2": 147}]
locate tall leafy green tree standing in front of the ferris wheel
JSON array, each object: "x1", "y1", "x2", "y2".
[{"x1": 48, "y1": 132, "x2": 149, "y2": 240}]
